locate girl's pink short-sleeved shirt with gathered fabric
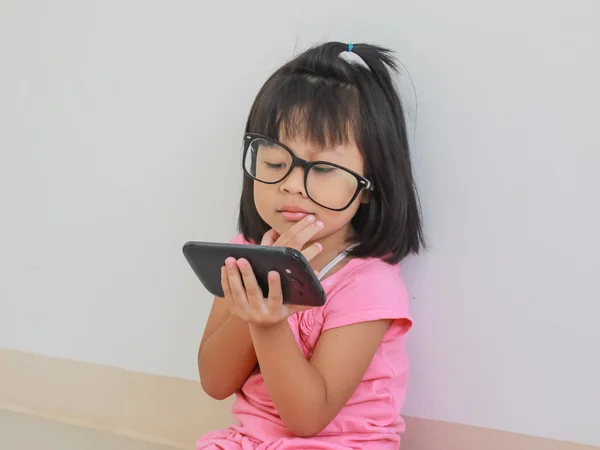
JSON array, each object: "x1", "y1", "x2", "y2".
[{"x1": 196, "y1": 236, "x2": 412, "y2": 450}]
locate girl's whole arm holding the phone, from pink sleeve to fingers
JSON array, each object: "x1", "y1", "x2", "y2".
[{"x1": 221, "y1": 244, "x2": 412, "y2": 437}]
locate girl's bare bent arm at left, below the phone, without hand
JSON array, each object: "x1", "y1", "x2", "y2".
[{"x1": 198, "y1": 297, "x2": 256, "y2": 400}]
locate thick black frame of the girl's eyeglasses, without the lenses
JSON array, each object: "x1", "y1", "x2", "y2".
[{"x1": 242, "y1": 133, "x2": 375, "y2": 211}]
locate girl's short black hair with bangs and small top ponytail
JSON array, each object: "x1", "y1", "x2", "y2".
[{"x1": 238, "y1": 42, "x2": 424, "y2": 263}]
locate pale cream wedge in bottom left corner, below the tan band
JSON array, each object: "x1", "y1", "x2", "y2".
[{"x1": 0, "y1": 410, "x2": 174, "y2": 450}]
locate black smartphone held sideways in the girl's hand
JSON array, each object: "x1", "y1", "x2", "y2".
[{"x1": 183, "y1": 241, "x2": 326, "y2": 306}]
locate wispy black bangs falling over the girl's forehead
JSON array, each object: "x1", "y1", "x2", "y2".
[{"x1": 248, "y1": 74, "x2": 360, "y2": 148}]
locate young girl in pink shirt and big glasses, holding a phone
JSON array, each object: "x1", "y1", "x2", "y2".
[{"x1": 196, "y1": 42, "x2": 422, "y2": 450}]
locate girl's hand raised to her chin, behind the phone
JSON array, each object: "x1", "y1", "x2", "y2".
[{"x1": 260, "y1": 215, "x2": 323, "y2": 261}]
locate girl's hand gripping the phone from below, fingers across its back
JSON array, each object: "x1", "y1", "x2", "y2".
[{"x1": 221, "y1": 258, "x2": 309, "y2": 327}]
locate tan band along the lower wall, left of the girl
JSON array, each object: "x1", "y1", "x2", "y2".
[{"x1": 0, "y1": 349, "x2": 231, "y2": 450}]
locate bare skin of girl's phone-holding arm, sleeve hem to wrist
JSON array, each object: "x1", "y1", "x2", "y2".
[{"x1": 250, "y1": 319, "x2": 392, "y2": 437}]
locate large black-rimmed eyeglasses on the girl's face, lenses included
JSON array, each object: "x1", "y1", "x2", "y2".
[{"x1": 243, "y1": 133, "x2": 373, "y2": 211}]
